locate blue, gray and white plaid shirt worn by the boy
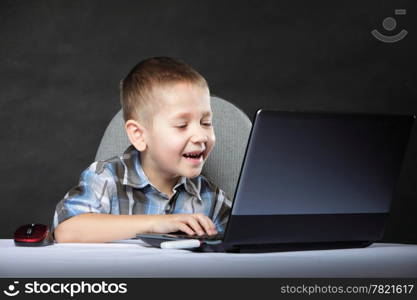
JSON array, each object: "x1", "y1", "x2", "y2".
[{"x1": 51, "y1": 146, "x2": 231, "y2": 233}]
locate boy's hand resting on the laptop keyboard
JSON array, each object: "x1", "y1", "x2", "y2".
[{"x1": 151, "y1": 214, "x2": 217, "y2": 235}]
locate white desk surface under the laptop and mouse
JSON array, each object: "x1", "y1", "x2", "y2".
[{"x1": 0, "y1": 240, "x2": 417, "y2": 278}]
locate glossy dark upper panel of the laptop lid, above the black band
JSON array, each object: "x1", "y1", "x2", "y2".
[{"x1": 232, "y1": 111, "x2": 414, "y2": 215}]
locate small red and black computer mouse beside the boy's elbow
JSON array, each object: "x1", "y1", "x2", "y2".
[{"x1": 14, "y1": 224, "x2": 54, "y2": 247}]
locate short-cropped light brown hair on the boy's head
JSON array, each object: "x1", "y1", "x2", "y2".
[{"x1": 120, "y1": 57, "x2": 208, "y2": 127}]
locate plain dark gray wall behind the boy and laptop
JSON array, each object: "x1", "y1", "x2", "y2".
[{"x1": 0, "y1": 0, "x2": 417, "y2": 243}]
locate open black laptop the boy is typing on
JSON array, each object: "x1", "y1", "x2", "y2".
[{"x1": 137, "y1": 110, "x2": 415, "y2": 252}]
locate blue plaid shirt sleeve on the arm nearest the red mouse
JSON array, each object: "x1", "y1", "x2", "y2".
[{"x1": 51, "y1": 162, "x2": 113, "y2": 233}]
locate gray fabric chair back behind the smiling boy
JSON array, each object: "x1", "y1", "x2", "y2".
[{"x1": 96, "y1": 97, "x2": 252, "y2": 200}]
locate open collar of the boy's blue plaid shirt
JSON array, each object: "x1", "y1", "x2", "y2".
[{"x1": 122, "y1": 145, "x2": 202, "y2": 200}]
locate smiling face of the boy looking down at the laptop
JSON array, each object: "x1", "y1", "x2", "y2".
[{"x1": 141, "y1": 83, "x2": 215, "y2": 178}]
